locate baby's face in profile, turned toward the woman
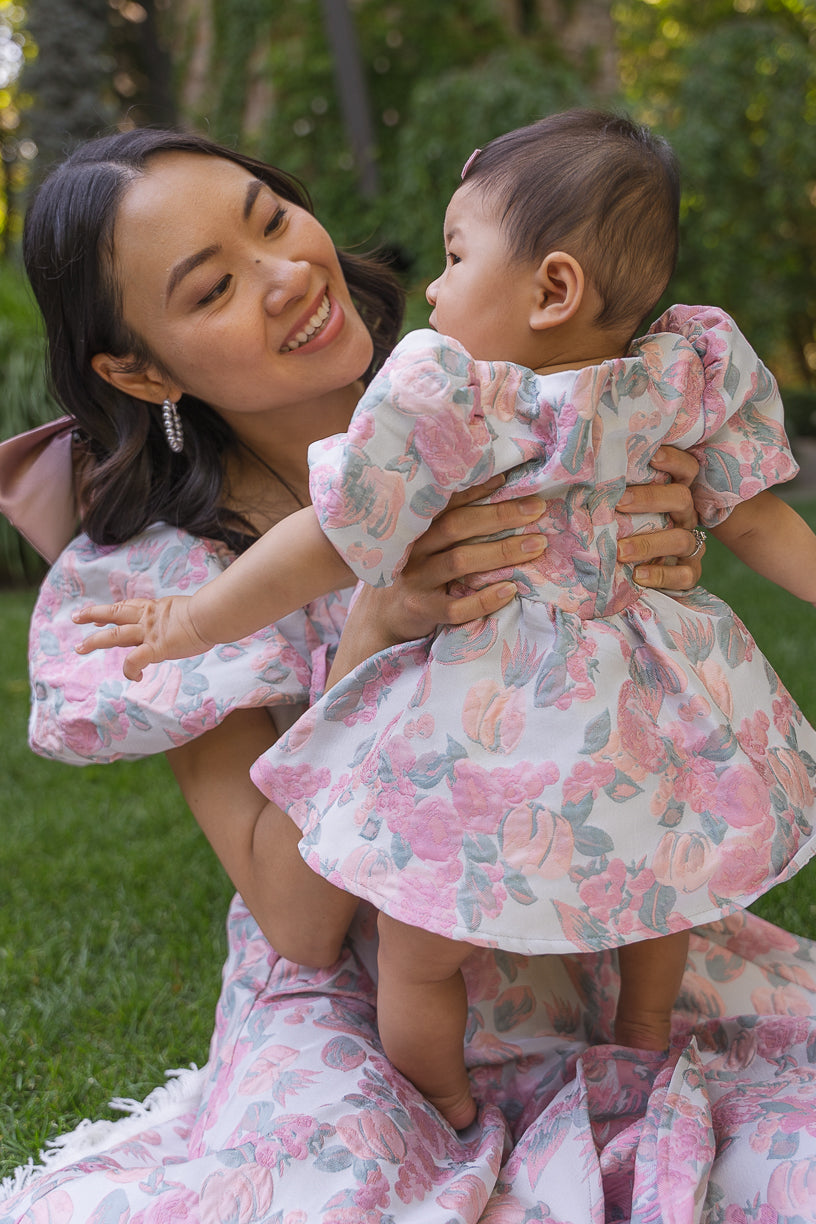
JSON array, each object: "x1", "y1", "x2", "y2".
[{"x1": 426, "y1": 184, "x2": 540, "y2": 368}]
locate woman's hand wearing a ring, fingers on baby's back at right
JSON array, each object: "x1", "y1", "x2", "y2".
[{"x1": 618, "y1": 447, "x2": 706, "y2": 591}]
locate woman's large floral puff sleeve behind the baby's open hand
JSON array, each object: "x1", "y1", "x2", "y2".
[{"x1": 28, "y1": 524, "x2": 345, "y2": 765}]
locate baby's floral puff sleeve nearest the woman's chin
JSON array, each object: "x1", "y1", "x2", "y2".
[{"x1": 308, "y1": 329, "x2": 532, "y2": 586}]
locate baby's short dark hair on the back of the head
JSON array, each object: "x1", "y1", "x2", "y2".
[{"x1": 464, "y1": 110, "x2": 680, "y2": 339}]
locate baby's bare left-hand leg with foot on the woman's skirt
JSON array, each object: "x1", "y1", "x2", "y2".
[{"x1": 377, "y1": 913, "x2": 476, "y2": 1130}]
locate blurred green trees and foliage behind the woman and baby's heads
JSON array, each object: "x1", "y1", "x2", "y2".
[{"x1": 0, "y1": 0, "x2": 816, "y2": 577}]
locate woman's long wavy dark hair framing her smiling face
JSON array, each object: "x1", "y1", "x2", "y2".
[{"x1": 23, "y1": 129, "x2": 402, "y2": 551}]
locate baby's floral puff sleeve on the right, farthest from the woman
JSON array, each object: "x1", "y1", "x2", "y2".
[{"x1": 639, "y1": 306, "x2": 799, "y2": 526}]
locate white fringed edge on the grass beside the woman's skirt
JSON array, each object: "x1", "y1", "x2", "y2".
[{"x1": 0, "y1": 1062, "x2": 207, "y2": 1203}]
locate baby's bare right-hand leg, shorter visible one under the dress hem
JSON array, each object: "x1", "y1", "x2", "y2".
[{"x1": 615, "y1": 930, "x2": 689, "y2": 1050}]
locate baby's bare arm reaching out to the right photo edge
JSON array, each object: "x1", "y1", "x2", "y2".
[{"x1": 712, "y1": 490, "x2": 816, "y2": 605}]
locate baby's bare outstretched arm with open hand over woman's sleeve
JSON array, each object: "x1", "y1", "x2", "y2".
[{"x1": 73, "y1": 506, "x2": 356, "y2": 681}]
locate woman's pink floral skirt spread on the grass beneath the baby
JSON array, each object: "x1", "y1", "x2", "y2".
[{"x1": 7, "y1": 897, "x2": 816, "y2": 1224}]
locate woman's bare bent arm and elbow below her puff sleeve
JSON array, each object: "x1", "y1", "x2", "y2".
[{"x1": 166, "y1": 710, "x2": 357, "y2": 967}]
